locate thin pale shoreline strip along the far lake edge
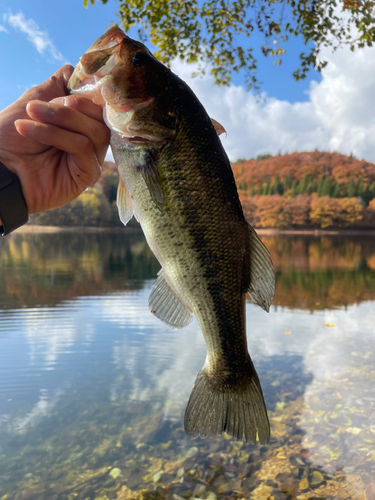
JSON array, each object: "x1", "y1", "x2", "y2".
[{"x1": 13, "y1": 224, "x2": 375, "y2": 236}]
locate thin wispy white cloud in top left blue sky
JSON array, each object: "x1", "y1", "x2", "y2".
[{"x1": 3, "y1": 12, "x2": 64, "y2": 61}]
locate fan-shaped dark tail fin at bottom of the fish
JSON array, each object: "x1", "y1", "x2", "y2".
[{"x1": 184, "y1": 363, "x2": 270, "y2": 444}]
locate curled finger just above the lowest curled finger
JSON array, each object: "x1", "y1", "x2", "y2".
[{"x1": 27, "y1": 99, "x2": 110, "y2": 161}]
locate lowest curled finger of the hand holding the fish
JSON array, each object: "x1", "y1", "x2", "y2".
[{"x1": 15, "y1": 120, "x2": 108, "y2": 182}]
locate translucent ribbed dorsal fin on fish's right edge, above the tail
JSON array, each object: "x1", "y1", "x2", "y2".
[{"x1": 248, "y1": 224, "x2": 275, "y2": 312}]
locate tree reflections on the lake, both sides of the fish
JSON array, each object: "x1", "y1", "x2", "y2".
[{"x1": 0, "y1": 229, "x2": 375, "y2": 311}]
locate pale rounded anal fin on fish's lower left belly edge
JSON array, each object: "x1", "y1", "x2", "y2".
[{"x1": 148, "y1": 269, "x2": 193, "y2": 329}]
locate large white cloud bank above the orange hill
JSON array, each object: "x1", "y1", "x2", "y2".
[{"x1": 172, "y1": 41, "x2": 375, "y2": 162}]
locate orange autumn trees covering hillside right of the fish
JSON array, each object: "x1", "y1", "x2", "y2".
[{"x1": 236, "y1": 151, "x2": 375, "y2": 229}]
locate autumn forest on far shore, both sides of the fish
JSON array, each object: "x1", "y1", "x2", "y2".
[{"x1": 31, "y1": 151, "x2": 375, "y2": 229}]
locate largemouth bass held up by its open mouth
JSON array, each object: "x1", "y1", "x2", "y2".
[{"x1": 68, "y1": 26, "x2": 275, "y2": 443}]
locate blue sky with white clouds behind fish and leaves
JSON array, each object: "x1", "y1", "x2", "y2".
[{"x1": 0, "y1": 0, "x2": 375, "y2": 162}]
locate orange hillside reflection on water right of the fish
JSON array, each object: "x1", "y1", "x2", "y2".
[{"x1": 263, "y1": 236, "x2": 375, "y2": 311}]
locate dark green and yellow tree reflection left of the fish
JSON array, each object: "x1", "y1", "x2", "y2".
[{"x1": 0, "y1": 230, "x2": 160, "y2": 308}]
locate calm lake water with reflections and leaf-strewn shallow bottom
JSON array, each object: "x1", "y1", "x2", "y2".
[{"x1": 0, "y1": 230, "x2": 375, "y2": 500}]
